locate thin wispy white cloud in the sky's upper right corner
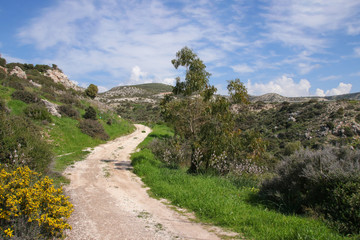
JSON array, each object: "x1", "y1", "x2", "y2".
[{"x1": 264, "y1": 0, "x2": 360, "y2": 52}]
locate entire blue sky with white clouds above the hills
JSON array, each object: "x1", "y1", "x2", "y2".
[{"x1": 0, "y1": 0, "x2": 360, "y2": 96}]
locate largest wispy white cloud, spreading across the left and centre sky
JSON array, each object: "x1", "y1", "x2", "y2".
[{"x1": 18, "y1": 0, "x2": 252, "y2": 88}]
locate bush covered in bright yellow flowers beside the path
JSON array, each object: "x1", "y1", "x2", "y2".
[{"x1": 0, "y1": 165, "x2": 73, "y2": 239}]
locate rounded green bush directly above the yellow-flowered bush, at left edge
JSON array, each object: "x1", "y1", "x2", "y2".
[{"x1": 0, "y1": 114, "x2": 53, "y2": 172}]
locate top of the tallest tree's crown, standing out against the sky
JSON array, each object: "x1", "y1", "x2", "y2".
[{"x1": 171, "y1": 47, "x2": 211, "y2": 95}]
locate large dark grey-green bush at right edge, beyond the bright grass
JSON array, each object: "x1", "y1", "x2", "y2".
[{"x1": 260, "y1": 147, "x2": 360, "y2": 234}]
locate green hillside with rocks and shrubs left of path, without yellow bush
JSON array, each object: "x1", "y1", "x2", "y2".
[{"x1": 0, "y1": 58, "x2": 133, "y2": 178}]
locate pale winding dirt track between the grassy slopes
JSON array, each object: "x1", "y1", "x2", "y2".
[{"x1": 64, "y1": 125, "x2": 239, "y2": 240}]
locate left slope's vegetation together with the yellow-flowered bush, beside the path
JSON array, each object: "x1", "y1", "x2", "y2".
[{"x1": 0, "y1": 58, "x2": 134, "y2": 239}]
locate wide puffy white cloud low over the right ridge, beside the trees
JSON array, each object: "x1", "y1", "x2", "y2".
[{"x1": 246, "y1": 75, "x2": 311, "y2": 97}]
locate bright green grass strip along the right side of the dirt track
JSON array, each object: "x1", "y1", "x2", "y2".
[{"x1": 132, "y1": 126, "x2": 356, "y2": 240}]
